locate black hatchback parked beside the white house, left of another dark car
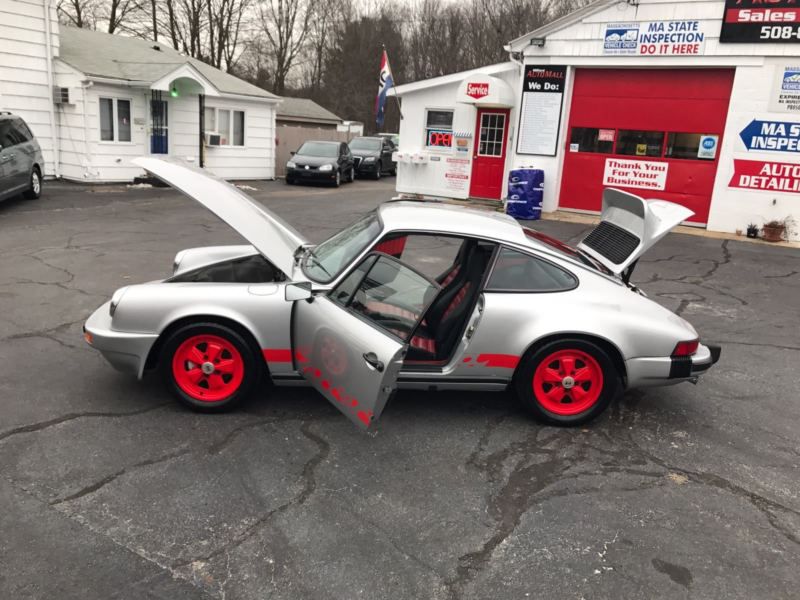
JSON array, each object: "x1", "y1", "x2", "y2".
[{"x1": 286, "y1": 141, "x2": 356, "y2": 187}]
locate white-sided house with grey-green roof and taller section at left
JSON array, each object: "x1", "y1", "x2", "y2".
[{"x1": 0, "y1": 0, "x2": 280, "y2": 182}]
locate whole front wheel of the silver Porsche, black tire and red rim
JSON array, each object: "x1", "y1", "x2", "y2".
[{"x1": 162, "y1": 323, "x2": 263, "y2": 411}]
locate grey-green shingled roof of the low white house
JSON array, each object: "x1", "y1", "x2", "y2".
[{"x1": 59, "y1": 26, "x2": 278, "y2": 100}]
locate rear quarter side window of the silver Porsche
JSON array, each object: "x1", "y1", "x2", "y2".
[{"x1": 487, "y1": 248, "x2": 578, "y2": 292}]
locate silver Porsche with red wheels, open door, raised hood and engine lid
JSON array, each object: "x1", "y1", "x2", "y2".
[{"x1": 84, "y1": 157, "x2": 720, "y2": 428}]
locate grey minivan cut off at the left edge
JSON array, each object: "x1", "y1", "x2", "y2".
[{"x1": 0, "y1": 112, "x2": 44, "y2": 200}]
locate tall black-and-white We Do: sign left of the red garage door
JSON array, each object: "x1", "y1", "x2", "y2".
[{"x1": 517, "y1": 65, "x2": 567, "y2": 156}]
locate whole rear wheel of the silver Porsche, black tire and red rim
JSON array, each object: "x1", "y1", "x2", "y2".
[{"x1": 514, "y1": 339, "x2": 622, "y2": 426}]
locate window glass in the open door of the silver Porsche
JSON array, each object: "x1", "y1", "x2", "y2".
[{"x1": 331, "y1": 255, "x2": 440, "y2": 340}]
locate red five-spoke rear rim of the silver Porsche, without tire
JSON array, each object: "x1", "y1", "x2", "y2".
[{"x1": 533, "y1": 349, "x2": 603, "y2": 416}]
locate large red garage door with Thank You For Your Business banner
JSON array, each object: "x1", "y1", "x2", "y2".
[{"x1": 559, "y1": 69, "x2": 734, "y2": 223}]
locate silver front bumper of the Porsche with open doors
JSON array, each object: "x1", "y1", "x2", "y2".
[{"x1": 83, "y1": 301, "x2": 158, "y2": 379}]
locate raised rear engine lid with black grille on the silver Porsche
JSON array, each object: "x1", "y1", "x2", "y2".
[{"x1": 578, "y1": 188, "x2": 694, "y2": 275}]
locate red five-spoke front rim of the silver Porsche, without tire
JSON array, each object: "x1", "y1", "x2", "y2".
[{"x1": 172, "y1": 334, "x2": 244, "y2": 402}]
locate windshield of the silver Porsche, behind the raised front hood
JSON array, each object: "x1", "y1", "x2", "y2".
[{"x1": 303, "y1": 213, "x2": 381, "y2": 283}]
